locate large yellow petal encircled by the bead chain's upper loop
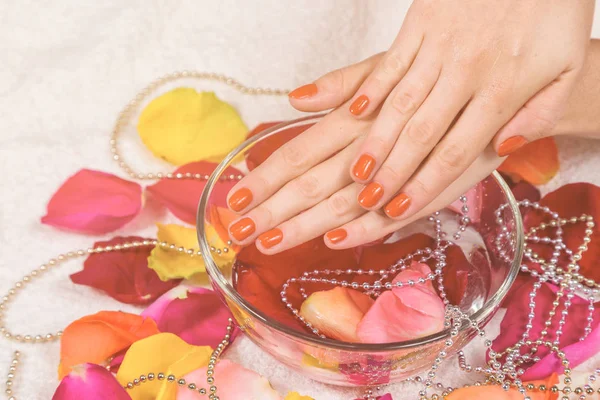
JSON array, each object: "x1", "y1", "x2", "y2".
[{"x1": 137, "y1": 88, "x2": 248, "y2": 165}]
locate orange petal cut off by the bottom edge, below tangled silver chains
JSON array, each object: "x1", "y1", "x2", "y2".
[{"x1": 446, "y1": 375, "x2": 558, "y2": 400}]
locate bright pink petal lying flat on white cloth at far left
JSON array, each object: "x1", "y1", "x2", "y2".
[{"x1": 41, "y1": 169, "x2": 142, "y2": 234}]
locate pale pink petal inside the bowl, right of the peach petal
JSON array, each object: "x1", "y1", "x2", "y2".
[{"x1": 357, "y1": 262, "x2": 444, "y2": 343}]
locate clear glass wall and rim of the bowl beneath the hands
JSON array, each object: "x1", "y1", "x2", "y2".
[{"x1": 197, "y1": 115, "x2": 523, "y2": 386}]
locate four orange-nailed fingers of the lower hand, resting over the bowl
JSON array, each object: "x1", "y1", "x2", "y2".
[{"x1": 228, "y1": 94, "x2": 502, "y2": 254}]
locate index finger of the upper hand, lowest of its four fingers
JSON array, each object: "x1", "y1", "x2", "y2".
[{"x1": 384, "y1": 92, "x2": 522, "y2": 219}]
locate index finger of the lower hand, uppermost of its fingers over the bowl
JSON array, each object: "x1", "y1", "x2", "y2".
[{"x1": 229, "y1": 141, "x2": 360, "y2": 247}]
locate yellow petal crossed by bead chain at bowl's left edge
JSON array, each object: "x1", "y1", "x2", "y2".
[{"x1": 148, "y1": 224, "x2": 235, "y2": 283}]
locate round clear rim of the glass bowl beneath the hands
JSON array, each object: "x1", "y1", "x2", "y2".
[{"x1": 196, "y1": 114, "x2": 524, "y2": 353}]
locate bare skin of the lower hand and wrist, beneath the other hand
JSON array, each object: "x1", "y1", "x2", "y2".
[{"x1": 226, "y1": 26, "x2": 600, "y2": 254}]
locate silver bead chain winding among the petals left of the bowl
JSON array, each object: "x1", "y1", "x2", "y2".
[{"x1": 0, "y1": 71, "x2": 289, "y2": 400}]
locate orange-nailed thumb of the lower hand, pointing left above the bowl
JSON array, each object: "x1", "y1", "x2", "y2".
[{"x1": 289, "y1": 53, "x2": 383, "y2": 112}]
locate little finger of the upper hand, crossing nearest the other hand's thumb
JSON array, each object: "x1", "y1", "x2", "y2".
[{"x1": 349, "y1": 22, "x2": 423, "y2": 117}]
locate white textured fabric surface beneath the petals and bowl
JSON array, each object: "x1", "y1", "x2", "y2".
[{"x1": 0, "y1": 0, "x2": 600, "y2": 400}]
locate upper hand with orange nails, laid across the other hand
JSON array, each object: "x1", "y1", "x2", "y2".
[{"x1": 290, "y1": 0, "x2": 593, "y2": 219}]
